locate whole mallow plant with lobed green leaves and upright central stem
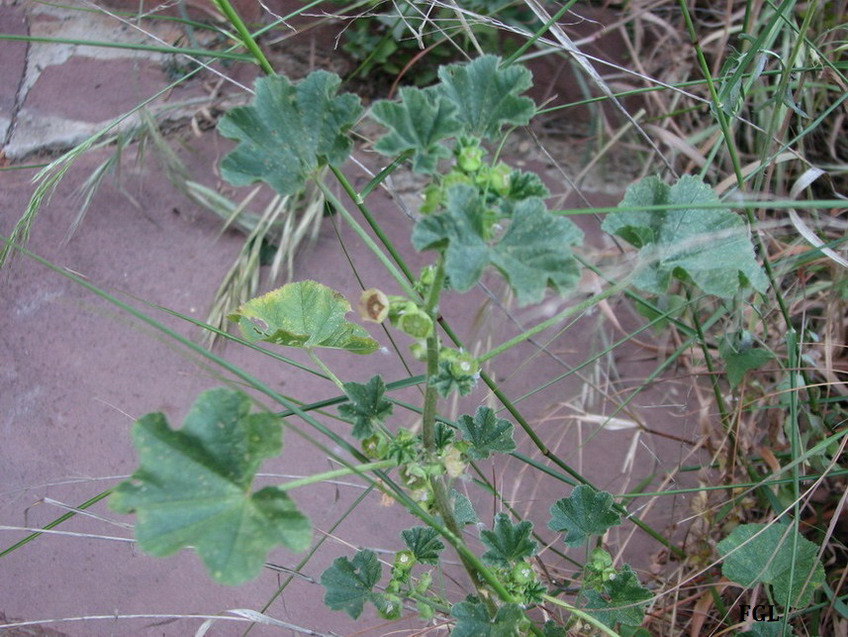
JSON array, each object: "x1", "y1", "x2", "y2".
[{"x1": 96, "y1": 51, "x2": 824, "y2": 637}]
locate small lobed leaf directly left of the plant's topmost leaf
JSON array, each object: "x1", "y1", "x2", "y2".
[{"x1": 371, "y1": 87, "x2": 462, "y2": 173}]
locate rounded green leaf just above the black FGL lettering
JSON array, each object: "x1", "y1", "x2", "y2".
[{"x1": 716, "y1": 524, "x2": 825, "y2": 608}]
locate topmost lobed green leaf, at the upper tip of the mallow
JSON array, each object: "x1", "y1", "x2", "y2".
[{"x1": 436, "y1": 55, "x2": 536, "y2": 139}]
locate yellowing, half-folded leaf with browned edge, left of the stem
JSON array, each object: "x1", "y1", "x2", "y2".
[{"x1": 227, "y1": 281, "x2": 380, "y2": 354}]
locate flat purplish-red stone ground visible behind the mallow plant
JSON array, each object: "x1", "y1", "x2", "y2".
[{"x1": 0, "y1": 5, "x2": 696, "y2": 637}]
